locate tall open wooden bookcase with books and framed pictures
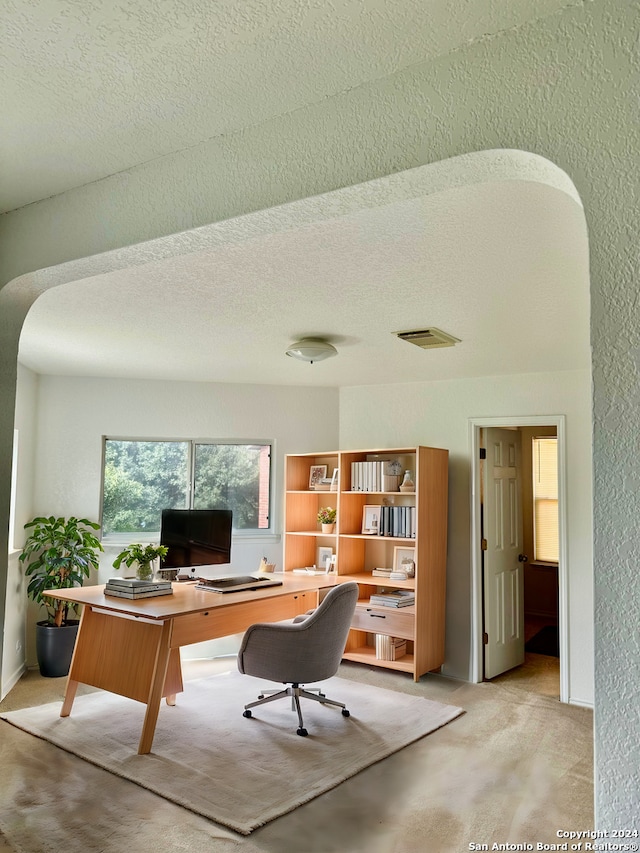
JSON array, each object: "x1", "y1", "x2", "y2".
[{"x1": 284, "y1": 446, "x2": 449, "y2": 681}]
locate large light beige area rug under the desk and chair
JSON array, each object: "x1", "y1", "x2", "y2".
[{"x1": 0, "y1": 672, "x2": 463, "y2": 835}]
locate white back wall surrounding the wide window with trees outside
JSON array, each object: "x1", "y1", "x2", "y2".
[{"x1": 22, "y1": 376, "x2": 338, "y2": 666}]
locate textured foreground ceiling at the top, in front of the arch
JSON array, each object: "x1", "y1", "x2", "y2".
[{"x1": 0, "y1": 0, "x2": 570, "y2": 211}]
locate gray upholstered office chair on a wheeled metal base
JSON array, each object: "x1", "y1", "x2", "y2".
[{"x1": 238, "y1": 582, "x2": 358, "y2": 737}]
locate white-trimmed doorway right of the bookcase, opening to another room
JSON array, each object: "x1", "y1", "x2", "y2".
[{"x1": 470, "y1": 415, "x2": 569, "y2": 702}]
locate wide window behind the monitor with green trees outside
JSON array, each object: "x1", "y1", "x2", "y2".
[{"x1": 102, "y1": 438, "x2": 271, "y2": 536}]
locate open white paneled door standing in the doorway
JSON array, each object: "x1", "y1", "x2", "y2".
[{"x1": 483, "y1": 428, "x2": 524, "y2": 678}]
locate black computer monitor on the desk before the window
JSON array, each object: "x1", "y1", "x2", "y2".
[{"x1": 160, "y1": 509, "x2": 232, "y2": 569}]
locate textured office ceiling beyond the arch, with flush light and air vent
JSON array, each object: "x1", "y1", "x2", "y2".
[{"x1": 20, "y1": 158, "x2": 589, "y2": 386}]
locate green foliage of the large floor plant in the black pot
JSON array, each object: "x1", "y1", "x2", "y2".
[{"x1": 18, "y1": 515, "x2": 103, "y2": 628}]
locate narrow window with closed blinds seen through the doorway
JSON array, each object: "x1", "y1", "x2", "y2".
[{"x1": 533, "y1": 438, "x2": 559, "y2": 563}]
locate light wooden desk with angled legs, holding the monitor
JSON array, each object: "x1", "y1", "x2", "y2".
[{"x1": 45, "y1": 573, "x2": 335, "y2": 755}]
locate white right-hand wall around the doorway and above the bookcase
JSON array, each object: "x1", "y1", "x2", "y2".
[{"x1": 340, "y1": 368, "x2": 594, "y2": 704}]
